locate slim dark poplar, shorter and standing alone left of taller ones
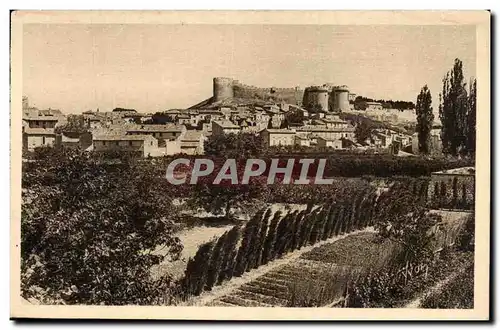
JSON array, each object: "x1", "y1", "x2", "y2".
[{"x1": 415, "y1": 85, "x2": 434, "y2": 154}]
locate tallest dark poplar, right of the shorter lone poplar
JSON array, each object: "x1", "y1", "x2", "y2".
[{"x1": 439, "y1": 59, "x2": 468, "y2": 156}]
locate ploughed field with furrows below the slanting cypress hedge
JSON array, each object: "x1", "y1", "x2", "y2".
[{"x1": 207, "y1": 233, "x2": 394, "y2": 307}]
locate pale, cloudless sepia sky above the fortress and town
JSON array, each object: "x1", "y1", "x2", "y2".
[{"x1": 23, "y1": 24, "x2": 476, "y2": 113}]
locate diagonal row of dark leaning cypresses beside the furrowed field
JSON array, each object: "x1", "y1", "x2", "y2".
[{"x1": 182, "y1": 182, "x2": 384, "y2": 295}]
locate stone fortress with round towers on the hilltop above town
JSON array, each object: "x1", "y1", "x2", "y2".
[{"x1": 190, "y1": 77, "x2": 355, "y2": 112}]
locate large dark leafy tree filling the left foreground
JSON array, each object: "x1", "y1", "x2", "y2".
[{"x1": 21, "y1": 150, "x2": 182, "y2": 305}]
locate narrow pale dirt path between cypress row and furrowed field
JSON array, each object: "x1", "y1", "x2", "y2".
[{"x1": 183, "y1": 227, "x2": 375, "y2": 306}]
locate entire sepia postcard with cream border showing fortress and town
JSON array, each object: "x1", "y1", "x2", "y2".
[{"x1": 10, "y1": 11, "x2": 491, "y2": 321}]
